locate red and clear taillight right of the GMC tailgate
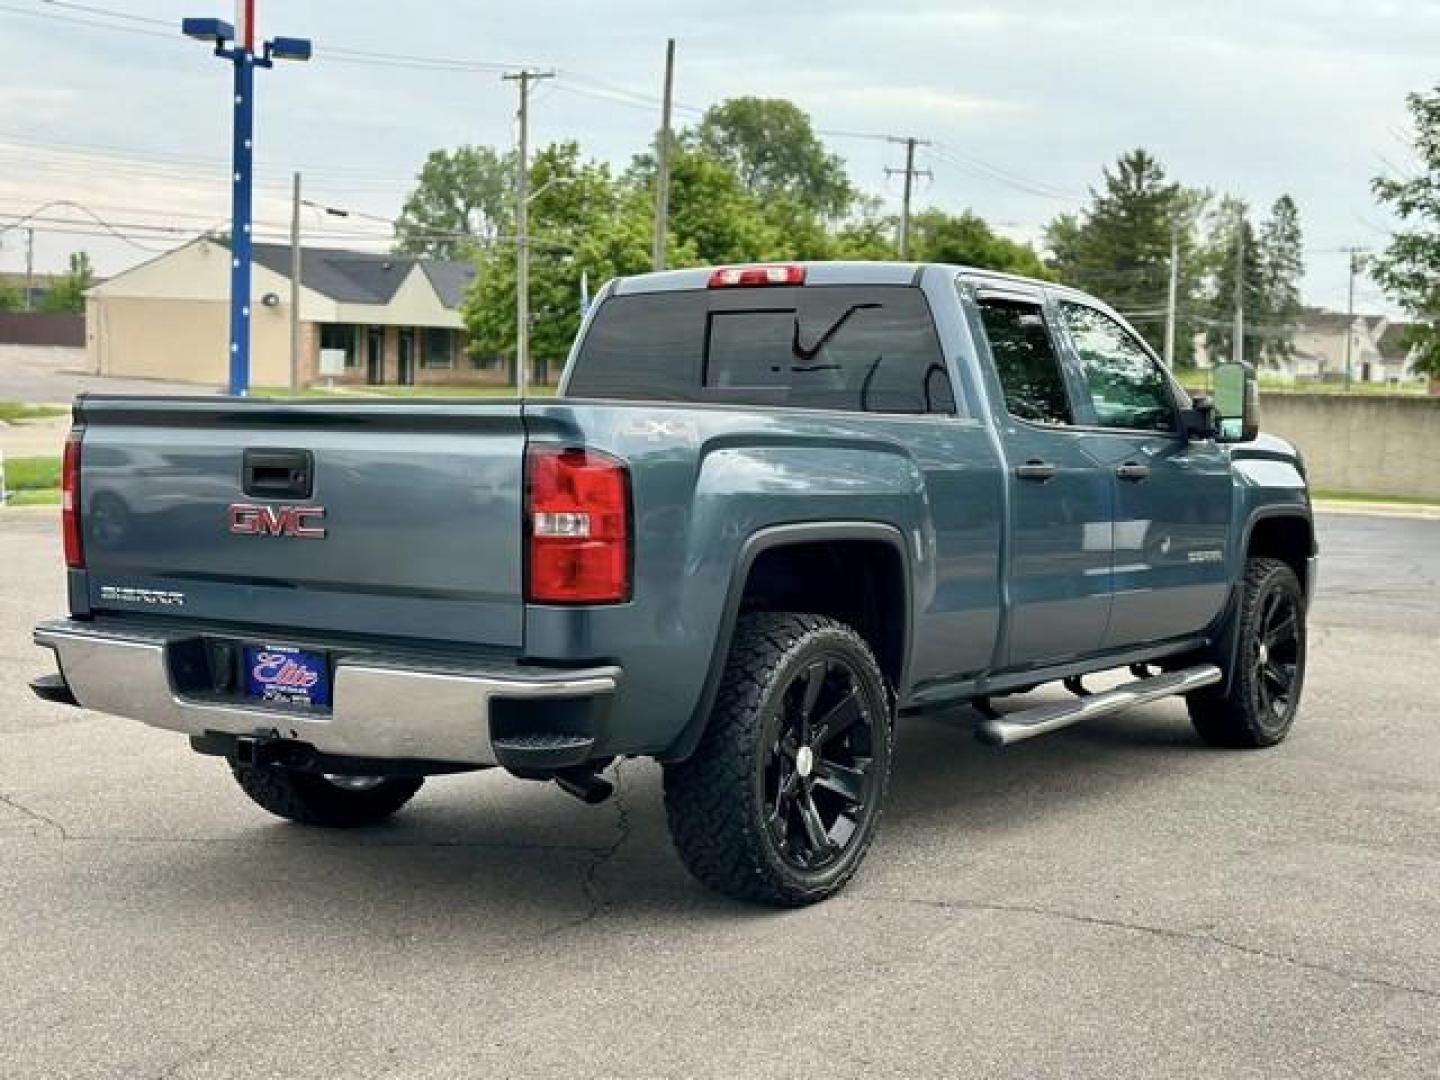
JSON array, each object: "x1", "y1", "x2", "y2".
[{"x1": 526, "y1": 446, "x2": 631, "y2": 603}]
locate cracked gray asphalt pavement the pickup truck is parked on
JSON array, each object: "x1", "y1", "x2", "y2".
[{"x1": 0, "y1": 516, "x2": 1440, "y2": 1080}]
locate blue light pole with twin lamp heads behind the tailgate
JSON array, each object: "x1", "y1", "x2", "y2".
[{"x1": 180, "y1": 0, "x2": 311, "y2": 397}]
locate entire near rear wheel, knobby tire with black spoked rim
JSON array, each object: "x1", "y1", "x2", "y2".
[{"x1": 665, "y1": 613, "x2": 893, "y2": 907}]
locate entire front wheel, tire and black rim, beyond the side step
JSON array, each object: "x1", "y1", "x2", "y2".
[{"x1": 1188, "y1": 559, "x2": 1306, "y2": 749}]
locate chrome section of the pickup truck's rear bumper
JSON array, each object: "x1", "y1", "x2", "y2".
[{"x1": 35, "y1": 619, "x2": 621, "y2": 765}]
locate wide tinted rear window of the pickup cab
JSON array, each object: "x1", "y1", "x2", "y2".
[{"x1": 569, "y1": 285, "x2": 955, "y2": 413}]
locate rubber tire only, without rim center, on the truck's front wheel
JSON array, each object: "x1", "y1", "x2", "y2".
[{"x1": 1187, "y1": 559, "x2": 1306, "y2": 750}]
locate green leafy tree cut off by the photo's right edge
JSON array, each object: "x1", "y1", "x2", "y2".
[{"x1": 1371, "y1": 85, "x2": 1440, "y2": 386}]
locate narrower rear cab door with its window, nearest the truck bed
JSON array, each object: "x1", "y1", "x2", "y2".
[{"x1": 976, "y1": 288, "x2": 1113, "y2": 668}]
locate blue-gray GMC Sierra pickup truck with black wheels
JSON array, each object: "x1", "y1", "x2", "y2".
[{"x1": 33, "y1": 264, "x2": 1316, "y2": 904}]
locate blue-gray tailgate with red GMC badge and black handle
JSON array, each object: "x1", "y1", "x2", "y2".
[{"x1": 78, "y1": 397, "x2": 526, "y2": 648}]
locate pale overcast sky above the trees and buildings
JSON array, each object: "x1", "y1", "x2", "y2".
[{"x1": 0, "y1": 0, "x2": 1440, "y2": 310}]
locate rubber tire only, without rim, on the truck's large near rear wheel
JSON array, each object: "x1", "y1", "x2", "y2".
[{"x1": 664, "y1": 613, "x2": 894, "y2": 907}]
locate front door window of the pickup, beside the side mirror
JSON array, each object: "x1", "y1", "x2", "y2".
[{"x1": 1060, "y1": 302, "x2": 1175, "y2": 431}]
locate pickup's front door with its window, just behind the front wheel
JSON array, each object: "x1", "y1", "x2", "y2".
[{"x1": 1057, "y1": 300, "x2": 1231, "y2": 648}]
